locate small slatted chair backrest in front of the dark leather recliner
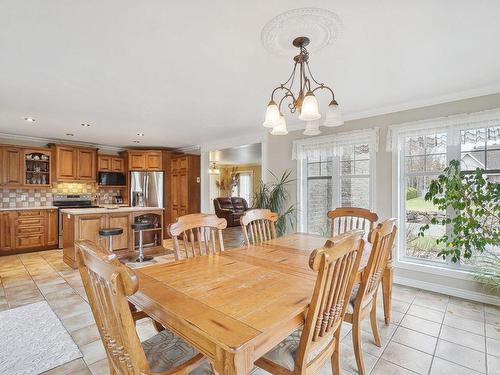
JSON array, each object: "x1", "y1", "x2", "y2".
[{"x1": 240, "y1": 209, "x2": 278, "y2": 246}]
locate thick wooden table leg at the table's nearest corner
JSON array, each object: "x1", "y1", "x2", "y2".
[{"x1": 213, "y1": 348, "x2": 254, "y2": 375}]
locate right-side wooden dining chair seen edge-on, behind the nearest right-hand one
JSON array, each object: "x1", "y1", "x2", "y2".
[{"x1": 344, "y1": 219, "x2": 397, "y2": 375}]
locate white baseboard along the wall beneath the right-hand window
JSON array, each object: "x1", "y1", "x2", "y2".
[{"x1": 394, "y1": 275, "x2": 500, "y2": 306}]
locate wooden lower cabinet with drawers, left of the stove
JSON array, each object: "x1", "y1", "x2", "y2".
[{"x1": 0, "y1": 209, "x2": 57, "y2": 255}]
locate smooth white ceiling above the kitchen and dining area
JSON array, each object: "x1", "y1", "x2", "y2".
[{"x1": 0, "y1": 0, "x2": 500, "y2": 147}]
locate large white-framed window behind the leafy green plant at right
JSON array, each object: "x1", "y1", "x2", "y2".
[{"x1": 387, "y1": 111, "x2": 500, "y2": 268}]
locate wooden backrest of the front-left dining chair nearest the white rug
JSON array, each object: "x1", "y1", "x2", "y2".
[{"x1": 75, "y1": 241, "x2": 150, "y2": 375}]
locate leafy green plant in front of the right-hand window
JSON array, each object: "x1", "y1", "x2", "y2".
[{"x1": 418, "y1": 160, "x2": 500, "y2": 291}]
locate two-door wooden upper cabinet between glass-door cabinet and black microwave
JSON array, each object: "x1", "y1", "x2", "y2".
[{"x1": 51, "y1": 145, "x2": 97, "y2": 181}]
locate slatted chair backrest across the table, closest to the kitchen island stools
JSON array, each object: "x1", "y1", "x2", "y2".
[{"x1": 168, "y1": 214, "x2": 227, "y2": 260}]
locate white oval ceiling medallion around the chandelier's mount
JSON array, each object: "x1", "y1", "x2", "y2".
[{"x1": 261, "y1": 8, "x2": 344, "y2": 56}]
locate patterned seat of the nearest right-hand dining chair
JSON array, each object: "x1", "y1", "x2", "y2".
[{"x1": 264, "y1": 328, "x2": 333, "y2": 371}]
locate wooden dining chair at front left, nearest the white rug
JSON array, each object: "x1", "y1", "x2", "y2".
[{"x1": 75, "y1": 241, "x2": 210, "y2": 375}]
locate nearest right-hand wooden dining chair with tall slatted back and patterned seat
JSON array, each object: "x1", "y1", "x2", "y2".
[{"x1": 255, "y1": 230, "x2": 364, "y2": 375}]
